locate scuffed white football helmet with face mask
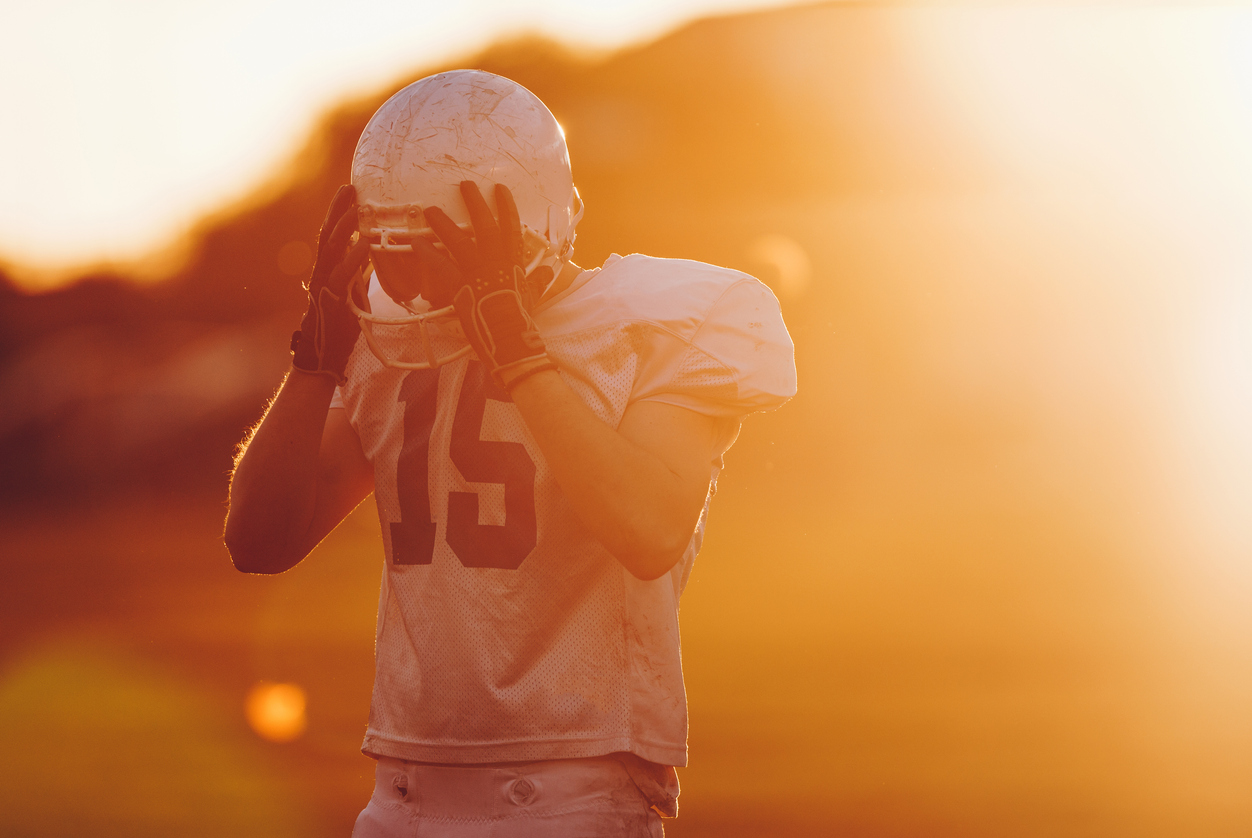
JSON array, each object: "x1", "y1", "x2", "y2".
[{"x1": 348, "y1": 70, "x2": 583, "y2": 370}]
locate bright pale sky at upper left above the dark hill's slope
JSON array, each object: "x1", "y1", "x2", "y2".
[{"x1": 0, "y1": 0, "x2": 784, "y2": 282}]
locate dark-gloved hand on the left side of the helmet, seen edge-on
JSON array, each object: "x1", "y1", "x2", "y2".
[{"x1": 292, "y1": 184, "x2": 369, "y2": 385}]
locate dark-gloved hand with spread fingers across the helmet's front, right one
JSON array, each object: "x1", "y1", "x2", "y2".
[{"x1": 414, "y1": 180, "x2": 556, "y2": 390}]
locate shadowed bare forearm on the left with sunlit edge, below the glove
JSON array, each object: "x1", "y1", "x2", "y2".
[{"x1": 224, "y1": 371, "x2": 334, "y2": 574}]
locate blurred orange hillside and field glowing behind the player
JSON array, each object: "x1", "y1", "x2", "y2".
[{"x1": 0, "y1": 5, "x2": 1252, "y2": 838}]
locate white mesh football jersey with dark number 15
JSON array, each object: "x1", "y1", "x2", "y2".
[{"x1": 334, "y1": 256, "x2": 795, "y2": 765}]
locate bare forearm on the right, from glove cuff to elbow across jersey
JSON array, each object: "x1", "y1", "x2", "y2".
[{"x1": 512, "y1": 372, "x2": 707, "y2": 579}]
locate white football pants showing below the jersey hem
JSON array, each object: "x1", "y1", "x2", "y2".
[{"x1": 352, "y1": 757, "x2": 664, "y2": 838}]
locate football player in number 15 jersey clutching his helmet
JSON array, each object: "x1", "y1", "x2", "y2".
[{"x1": 225, "y1": 70, "x2": 795, "y2": 838}]
